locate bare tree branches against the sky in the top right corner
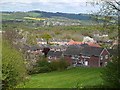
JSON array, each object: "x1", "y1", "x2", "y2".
[{"x1": 86, "y1": 0, "x2": 120, "y2": 15}]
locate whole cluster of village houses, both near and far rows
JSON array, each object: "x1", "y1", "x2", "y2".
[{"x1": 17, "y1": 34, "x2": 118, "y2": 67}]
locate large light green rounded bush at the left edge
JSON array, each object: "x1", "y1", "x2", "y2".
[{"x1": 2, "y1": 40, "x2": 26, "y2": 90}]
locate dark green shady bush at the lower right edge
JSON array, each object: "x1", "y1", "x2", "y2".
[{"x1": 102, "y1": 56, "x2": 120, "y2": 88}]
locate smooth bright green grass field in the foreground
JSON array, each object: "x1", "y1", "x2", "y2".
[{"x1": 18, "y1": 67, "x2": 103, "y2": 88}]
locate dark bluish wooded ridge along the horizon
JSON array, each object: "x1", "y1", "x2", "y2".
[{"x1": 29, "y1": 10, "x2": 91, "y2": 20}]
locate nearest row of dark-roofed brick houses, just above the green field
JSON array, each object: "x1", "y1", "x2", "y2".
[{"x1": 22, "y1": 43, "x2": 116, "y2": 67}]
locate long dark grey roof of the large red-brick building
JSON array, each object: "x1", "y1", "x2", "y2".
[{"x1": 63, "y1": 44, "x2": 103, "y2": 56}]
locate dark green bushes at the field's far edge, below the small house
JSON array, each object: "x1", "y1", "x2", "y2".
[{"x1": 29, "y1": 57, "x2": 68, "y2": 74}]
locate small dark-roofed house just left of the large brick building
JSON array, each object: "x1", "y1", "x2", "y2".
[{"x1": 47, "y1": 51, "x2": 62, "y2": 62}]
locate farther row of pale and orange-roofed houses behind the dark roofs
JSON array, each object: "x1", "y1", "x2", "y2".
[{"x1": 37, "y1": 36, "x2": 116, "y2": 47}]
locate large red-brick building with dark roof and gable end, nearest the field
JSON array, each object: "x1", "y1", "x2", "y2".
[{"x1": 63, "y1": 44, "x2": 110, "y2": 67}]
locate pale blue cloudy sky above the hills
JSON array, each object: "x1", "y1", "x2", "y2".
[{"x1": 0, "y1": 0, "x2": 100, "y2": 14}]
